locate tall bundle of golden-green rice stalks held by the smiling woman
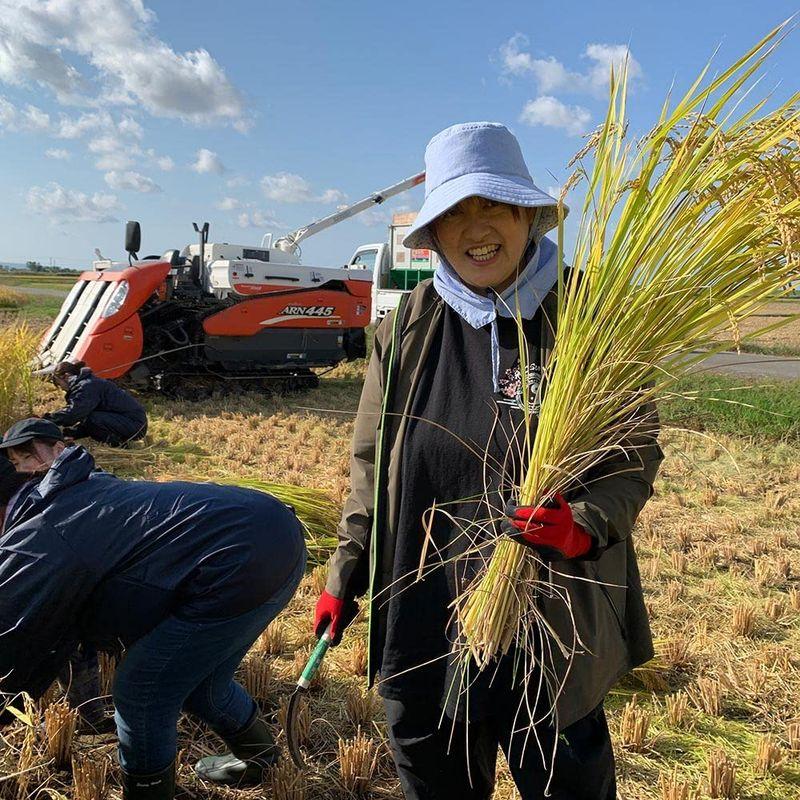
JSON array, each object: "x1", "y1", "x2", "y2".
[{"x1": 455, "y1": 25, "x2": 800, "y2": 669}]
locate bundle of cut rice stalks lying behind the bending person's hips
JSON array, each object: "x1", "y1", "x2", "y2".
[{"x1": 234, "y1": 478, "x2": 340, "y2": 565}]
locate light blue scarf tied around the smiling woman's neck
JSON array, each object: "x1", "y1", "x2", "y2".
[{"x1": 433, "y1": 237, "x2": 558, "y2": 392}]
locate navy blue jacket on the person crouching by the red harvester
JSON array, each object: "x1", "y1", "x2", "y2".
[{"x1": 47, "y1": 367, "x2": 147, "y2": 439}]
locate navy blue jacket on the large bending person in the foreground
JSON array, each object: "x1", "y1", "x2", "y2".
[{"x1": 0, "y1": 447, "x2": 304, "y2": 696}]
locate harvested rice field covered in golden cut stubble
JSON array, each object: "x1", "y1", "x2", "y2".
[{"x1": 0, "y1": 352, "x2": 800, "y2": 800}]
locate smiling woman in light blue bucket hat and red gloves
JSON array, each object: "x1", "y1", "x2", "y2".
[{"x1": 315, "y1": 123, "x2": 662, "y2": 800}]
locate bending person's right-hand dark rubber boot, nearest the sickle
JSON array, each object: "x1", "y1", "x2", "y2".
[{"x1": 194, "y1": 709, "x2": 278, "y2": 786}]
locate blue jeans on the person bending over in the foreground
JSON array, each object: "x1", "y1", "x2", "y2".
[{"x1": 113, "y1": 551, "x2": 306, "y2": 775}]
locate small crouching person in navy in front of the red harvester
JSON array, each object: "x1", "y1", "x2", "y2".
[{"x1": 44, "y1": 361, "x2": 147, "y2": 447}]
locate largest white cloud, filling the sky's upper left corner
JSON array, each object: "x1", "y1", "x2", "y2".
[{"x1": 0, "y1": 0, "x2": 247, "y2": 129}]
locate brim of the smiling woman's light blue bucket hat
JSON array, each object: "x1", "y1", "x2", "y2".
[{"x1": 403, "y1": 172, "x2": 569, "y2": 250}]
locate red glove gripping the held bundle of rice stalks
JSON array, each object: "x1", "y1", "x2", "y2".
[{"x1": 503, "y1": 494, "x2": 592, "y2": 561}]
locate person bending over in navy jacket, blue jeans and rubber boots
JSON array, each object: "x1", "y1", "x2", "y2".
[{"x1": 0, "y1": 432, "x2": 306, "y2": 800}]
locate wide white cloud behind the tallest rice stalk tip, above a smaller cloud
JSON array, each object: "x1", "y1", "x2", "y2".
[{"x1": 500, "y1": 33, "x2": 642, "y2": 94}]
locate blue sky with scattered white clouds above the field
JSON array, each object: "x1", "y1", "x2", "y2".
[{"x1": 0, "y1": 0, "x2": 800, "y2": 267}]
